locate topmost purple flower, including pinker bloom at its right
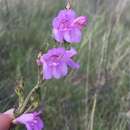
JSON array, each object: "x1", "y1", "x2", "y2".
[{"x1": 52, "y1": 9, "x2": 88, "y2": 43}]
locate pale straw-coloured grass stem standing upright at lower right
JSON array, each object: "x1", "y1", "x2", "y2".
[{"x1": 90, "y1": 93, "x2": 97, "y2": 130}]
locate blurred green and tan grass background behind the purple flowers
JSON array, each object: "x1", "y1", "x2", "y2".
[{"x1": 0, "y1": 0, "x2": 130, "y2": 130}]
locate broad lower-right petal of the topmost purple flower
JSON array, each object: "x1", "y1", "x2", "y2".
[{"x1": 64, "y1": 28, "x2": 82, "y2": 43}]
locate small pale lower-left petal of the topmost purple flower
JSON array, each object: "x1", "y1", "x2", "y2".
[{"x1": 53, "y1": 28, "x2": 63, "y2": 43}]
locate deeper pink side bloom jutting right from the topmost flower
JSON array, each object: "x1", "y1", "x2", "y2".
[{"x1": 72, "y1": 16, "x2": 88, "y2": 29}]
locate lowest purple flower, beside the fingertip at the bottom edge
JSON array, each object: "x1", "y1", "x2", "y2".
[{"x1": 13, "y1": 112, "x2": 44, "y2": 130}]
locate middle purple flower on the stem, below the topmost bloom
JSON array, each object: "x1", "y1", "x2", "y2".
[{"x1": 37, "y1": 48, "x2": 79, "y2": 79}]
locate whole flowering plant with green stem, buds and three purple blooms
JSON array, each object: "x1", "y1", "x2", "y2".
[{"x1": 0, "y1": 0, "x2": 88, "y2": 130}]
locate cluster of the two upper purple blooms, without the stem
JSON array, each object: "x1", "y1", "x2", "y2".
[{"x1": 37, "y1": 9, "x2": 88, "y2": 80}]
